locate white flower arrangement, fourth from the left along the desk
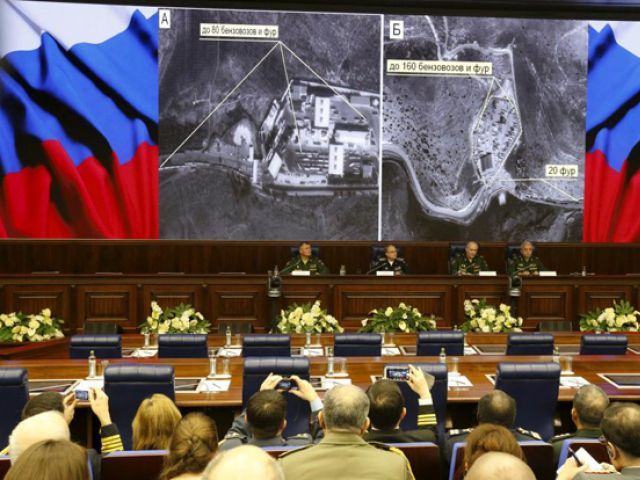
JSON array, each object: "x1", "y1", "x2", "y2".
[{"x1": 360, "y1": 303, "x2": 436, "y2": 333}]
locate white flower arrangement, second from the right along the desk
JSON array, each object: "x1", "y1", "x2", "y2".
[{"x1": 462, "y1": 298, "x2": 522, "y2": 333}]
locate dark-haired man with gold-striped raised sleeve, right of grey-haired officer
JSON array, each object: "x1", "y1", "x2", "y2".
[{"x1": 364, "y1": 365, "x2": 436, "y2": 443}]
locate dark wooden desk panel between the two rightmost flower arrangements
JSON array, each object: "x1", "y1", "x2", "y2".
[{"x1": 517, "y1": 280, "x2": 577, "y2": 330}]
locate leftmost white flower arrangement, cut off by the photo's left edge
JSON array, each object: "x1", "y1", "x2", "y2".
[{"x1": 0, "y1": 308, "x2": 64, "y2": 342}]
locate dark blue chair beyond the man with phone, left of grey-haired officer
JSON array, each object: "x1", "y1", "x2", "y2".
[{"x1": 242, "y1": 357, "x2": 311, "y2": 437}]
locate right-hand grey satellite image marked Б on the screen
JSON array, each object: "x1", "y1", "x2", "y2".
[{"x1": 382, "y1": 16, "x2": 587, "y2": 241}]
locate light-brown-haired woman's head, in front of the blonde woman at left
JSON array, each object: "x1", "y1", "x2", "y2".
[{"x1": 160, "y1": 412, "x2": 218, "y2": 480}]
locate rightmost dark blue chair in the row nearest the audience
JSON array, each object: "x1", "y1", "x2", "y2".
[{"x1": 496, "y1": 362, "x2": 560, "y2": 441}]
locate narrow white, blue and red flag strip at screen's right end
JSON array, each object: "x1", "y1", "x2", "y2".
[{"x1": 583, "y1": 22, "x2": 640, "y2": 242}]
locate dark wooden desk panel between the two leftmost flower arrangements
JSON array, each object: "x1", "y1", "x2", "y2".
[{"x1": 76, "y1": 285, "x2": 139, "y2": 332}]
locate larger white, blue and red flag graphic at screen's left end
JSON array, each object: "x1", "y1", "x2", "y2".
[{"x1": 0, "y1": 0, "x2": 158, "y2": 238}]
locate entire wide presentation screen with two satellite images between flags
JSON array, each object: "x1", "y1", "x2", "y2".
[{"x1": 0, "y1": 0, "x2": 640, "y2": 242}]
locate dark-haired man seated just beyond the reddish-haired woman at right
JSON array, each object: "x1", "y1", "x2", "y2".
[{"x1": 444, "y1": 390, "x2": 542, "y2": 463}]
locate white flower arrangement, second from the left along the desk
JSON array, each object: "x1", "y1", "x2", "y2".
[{"x1": 140, "y1": 301, "x2": 211, "y2": 335}]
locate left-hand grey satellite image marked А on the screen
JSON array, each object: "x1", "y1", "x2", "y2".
[{"x1": 159, "y1": 9, "x2": 381, "y2": 240}]
